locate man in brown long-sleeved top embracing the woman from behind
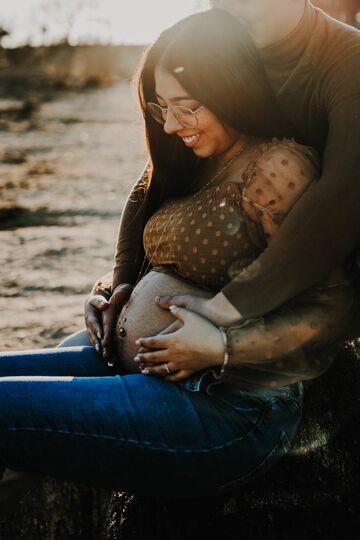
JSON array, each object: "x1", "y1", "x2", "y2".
[{"x1": 86, "y1": 0, "x2": 360, "y2": 358}]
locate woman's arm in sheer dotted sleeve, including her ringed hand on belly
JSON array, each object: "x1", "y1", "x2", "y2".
[{"x1": 135, "y1": 276, "x2": 354, "y2": 388}]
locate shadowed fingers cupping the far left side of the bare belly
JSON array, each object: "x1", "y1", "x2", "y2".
[{"x1": 85, "y1": 283, "x2": 132, "y2": 361}]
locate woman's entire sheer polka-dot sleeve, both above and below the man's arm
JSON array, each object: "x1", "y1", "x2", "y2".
[{"x1": 212, "y1": 143, "x2": 355, "y2": 388}]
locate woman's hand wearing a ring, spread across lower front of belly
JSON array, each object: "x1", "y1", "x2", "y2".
[{"x1": 134, "y1": 306, "x2": 224, "y2": 381}]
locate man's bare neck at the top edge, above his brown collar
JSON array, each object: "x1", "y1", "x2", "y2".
[{"x1": 236, "y1": 0, "x2": 306, "y2": 49}]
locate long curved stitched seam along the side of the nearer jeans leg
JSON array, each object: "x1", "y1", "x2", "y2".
[{"x1": 0, "y1": 407, "x2": 268, "y2": 454}]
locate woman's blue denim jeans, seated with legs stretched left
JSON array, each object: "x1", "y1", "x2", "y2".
[{"x1": 0, "y1": 346, "x2": 302, "y2": 497}]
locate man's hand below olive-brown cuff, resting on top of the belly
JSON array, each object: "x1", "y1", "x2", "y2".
[{"x1": 155, "y1": 293, "x2": 242, "y2": 326}]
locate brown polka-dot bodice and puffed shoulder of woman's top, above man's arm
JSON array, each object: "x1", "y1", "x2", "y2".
[{"x1": 143, "y1": 140, "x2": 318, "y2": 291}]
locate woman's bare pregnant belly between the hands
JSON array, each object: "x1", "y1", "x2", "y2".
[{"x1": 115, "y1": 271, "x2": 213, "y2": 373}]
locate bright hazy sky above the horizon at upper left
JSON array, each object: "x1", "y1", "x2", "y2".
[{"x1": 0, "y1": 0, "x2": 208, "y2": 47}]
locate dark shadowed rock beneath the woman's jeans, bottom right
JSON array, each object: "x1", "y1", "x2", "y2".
[{"x1": 106, "y1": 346, "x2": 360, "y2": 540}]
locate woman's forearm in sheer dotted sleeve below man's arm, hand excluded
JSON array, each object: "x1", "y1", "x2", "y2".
[{"x1": 217, "y1": 271, "x2": 356, "y2": 387}]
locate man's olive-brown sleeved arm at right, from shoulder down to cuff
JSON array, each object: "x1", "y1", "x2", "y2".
[{"x1": 222, "y1": 46, "x2": 360, "y2": 319}]
